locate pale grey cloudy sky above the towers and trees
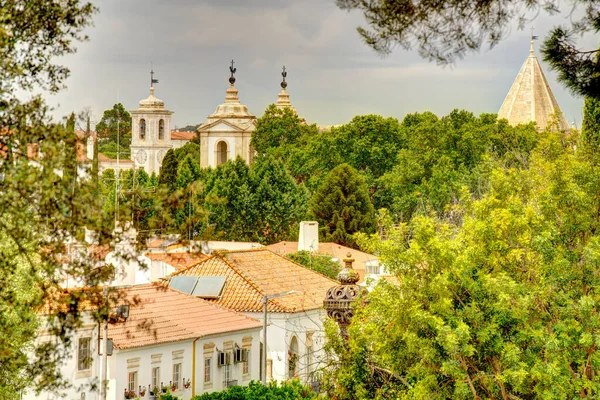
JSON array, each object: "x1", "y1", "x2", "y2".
[{"x1": 48, "y1": 0, "x2": 594, "y2": 127}]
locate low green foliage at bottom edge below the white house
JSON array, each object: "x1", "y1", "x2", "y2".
[{"x1": 192, "y1": 380, "x2": 318, "y2": 400}]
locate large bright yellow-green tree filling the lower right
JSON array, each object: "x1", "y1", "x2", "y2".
[{"x1": 327, "y1": 132, "x2": 600, "y2": 399}]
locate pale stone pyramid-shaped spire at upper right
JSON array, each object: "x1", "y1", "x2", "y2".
[{"x1": 498, "y1": 40, "x2": 569, "y2": 130}]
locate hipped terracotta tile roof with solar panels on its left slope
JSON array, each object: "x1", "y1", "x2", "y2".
[{"x1": 173, "y1": 248, "x2": 337, "y2": 312}]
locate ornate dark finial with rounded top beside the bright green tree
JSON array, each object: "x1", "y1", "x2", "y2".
[{"x1": 323, "y1": 253, "x2": 366, "y2": 339}]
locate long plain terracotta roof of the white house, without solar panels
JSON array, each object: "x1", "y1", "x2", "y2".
[{"x1": 108, "y1": 284, "x2": 262, "y2": 349}]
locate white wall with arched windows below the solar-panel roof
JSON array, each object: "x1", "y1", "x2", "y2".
[{"x1": 245, "y1": 309, "x2": 325, "y2": 382}]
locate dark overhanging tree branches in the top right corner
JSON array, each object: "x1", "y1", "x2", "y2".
[{"x1": 337, "y1": 0, "x2": 600, "y2": 98}]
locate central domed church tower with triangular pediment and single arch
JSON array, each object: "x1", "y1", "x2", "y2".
[{"x1": 197, "y1": 60, "x2": 256, "y2": 168}]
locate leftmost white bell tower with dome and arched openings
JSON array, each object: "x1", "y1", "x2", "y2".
[{"x1": 130, "y1": 71, "x2": 173, "y2": 175}]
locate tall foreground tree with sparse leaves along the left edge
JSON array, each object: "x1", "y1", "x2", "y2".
[{"x1": 0, "y1": 0, "x2": 137, "y2": 399}]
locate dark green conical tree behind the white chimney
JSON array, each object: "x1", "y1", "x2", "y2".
[{"x1": 309, "y1": 164, "x2": 375, "y2": 246}]
